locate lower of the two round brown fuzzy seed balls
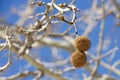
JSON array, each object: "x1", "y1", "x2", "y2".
[{"x1": 71, "y1": 50, "x2": 87, "y2": 68}]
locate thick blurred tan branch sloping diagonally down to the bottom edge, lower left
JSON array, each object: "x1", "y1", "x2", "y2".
[{"x1": 13, "y1": 43, "x2": 68, "y2": 80}]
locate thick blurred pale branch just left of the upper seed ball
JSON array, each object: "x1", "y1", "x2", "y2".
[{"x1": 33, "y1": 36, "x2": 75, "y2": 52}]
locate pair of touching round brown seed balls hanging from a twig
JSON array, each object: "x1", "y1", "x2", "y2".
[{"x1": 71, "y1": 36, "x2": 91, "y2": 68}]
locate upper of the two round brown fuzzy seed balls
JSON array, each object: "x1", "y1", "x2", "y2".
[{"x1": 75, "y1": 36, "x2": 91, "y2": 51}]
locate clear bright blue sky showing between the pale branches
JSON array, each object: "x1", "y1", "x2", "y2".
[{"x1": 0, "y1": 0, "x2": 120, "y2": 80}]
